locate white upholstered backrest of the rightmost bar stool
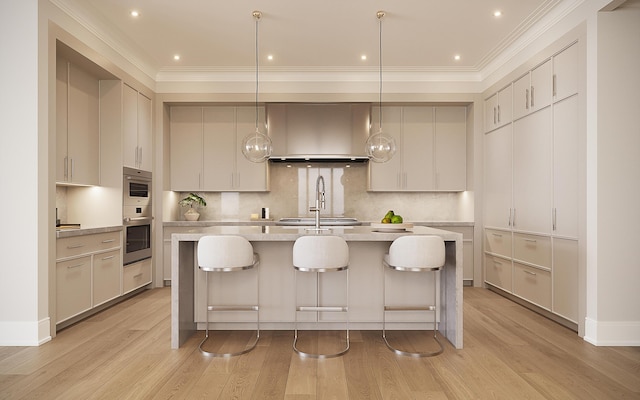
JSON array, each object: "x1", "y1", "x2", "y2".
[{"x1": 389, "y1": 235, "x2": 445, "y2": 268}]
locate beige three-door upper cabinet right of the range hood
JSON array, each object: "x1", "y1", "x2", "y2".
[{"x1": 369, "y1": 106, "x2": 467, "y2": 192}]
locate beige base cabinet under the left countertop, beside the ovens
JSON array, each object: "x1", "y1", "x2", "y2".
[{"x1": 56, "y1": 231, "x2": 122, "y2": 323}]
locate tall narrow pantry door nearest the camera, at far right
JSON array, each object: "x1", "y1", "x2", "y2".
[{"x1": 552, "y1": 95, "x2": 579, "y2": 238}]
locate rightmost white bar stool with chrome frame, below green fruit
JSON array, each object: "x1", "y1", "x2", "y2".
[{"x1": 382, "y1": 235, "x2": 445, "y2": 357}]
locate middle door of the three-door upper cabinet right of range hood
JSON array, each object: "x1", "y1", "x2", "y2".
[{"x1": 401, "y1": 107, "x2": 436, "y2": 191}]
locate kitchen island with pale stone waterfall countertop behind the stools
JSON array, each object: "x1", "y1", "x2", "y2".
[{"x1": 171, "y1": 226, "x2": 463, "y2": 348}]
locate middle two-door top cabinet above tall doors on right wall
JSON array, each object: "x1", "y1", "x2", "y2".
[{"x1": 513, "y1": 59, "x2": 553, "y2": 120}]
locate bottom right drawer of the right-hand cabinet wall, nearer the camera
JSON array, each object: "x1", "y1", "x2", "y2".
[{"x1": 513, "y1": 262, "x2": 551, "y2": 310}]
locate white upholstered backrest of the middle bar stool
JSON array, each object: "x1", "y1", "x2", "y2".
[{"x1": 293, "y1": 236, "x2": 349, "y2": 269}]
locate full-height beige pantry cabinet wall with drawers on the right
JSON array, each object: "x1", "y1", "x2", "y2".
[{"x1": 484, "y1": 42, "x2": 580, "y2": 327}]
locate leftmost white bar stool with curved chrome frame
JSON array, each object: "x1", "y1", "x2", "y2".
[{"x1": 198, "y1": 236, "x2": 260, "y2": 357}]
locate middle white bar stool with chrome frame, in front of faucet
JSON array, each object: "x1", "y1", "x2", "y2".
[{"x1": 293, "y1": 236, "x2": 349, "y2": 358}]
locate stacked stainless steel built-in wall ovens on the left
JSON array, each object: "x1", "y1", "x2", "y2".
[{"x1": 122, "y1": 167, "x2": 153, "y2": 265}]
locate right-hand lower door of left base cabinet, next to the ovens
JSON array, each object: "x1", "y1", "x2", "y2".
[{"x1": 93, "y1": 249, "x2": 122, "y2": 307}]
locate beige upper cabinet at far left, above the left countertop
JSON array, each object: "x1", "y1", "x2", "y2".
[{"x1": 56, "y1": 58, "x2": 100, "y2": 185}]
